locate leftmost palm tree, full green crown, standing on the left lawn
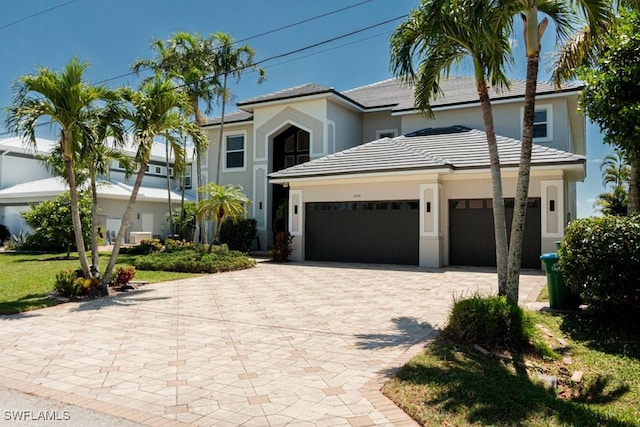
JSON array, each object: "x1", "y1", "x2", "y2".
[{"x1": 6, "y1": 58, "x2": 110, "y2": 277}]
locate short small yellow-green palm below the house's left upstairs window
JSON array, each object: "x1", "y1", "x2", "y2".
[{"x1": 198, "y1": 182, "x2": 251, "y2": 252}]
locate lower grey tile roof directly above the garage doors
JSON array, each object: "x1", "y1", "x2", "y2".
[{"x1": 269, "y1": 126, "x2": 585, "y2": 179}]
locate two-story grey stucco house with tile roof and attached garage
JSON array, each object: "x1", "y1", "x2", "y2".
[{"x1": 206, "y1": 77, "x2": 586, "y2": 268}]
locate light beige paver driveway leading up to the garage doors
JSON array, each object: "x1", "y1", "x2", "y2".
[{"x1": 0, "y1": 263, "x2": 545, "y2": 426}]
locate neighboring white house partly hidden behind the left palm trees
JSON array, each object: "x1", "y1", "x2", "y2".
[{"x1": 0, "y1": 138, "x2": 196, "y2": 243}]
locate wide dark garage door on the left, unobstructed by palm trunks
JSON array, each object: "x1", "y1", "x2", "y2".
[{"x1": 305, "y1": 200, "x2": 420, "y2": 265}]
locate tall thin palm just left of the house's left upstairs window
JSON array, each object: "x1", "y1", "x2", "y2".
[{"x1": 213, "y1": 32, "x2": 267, "y2": 184}]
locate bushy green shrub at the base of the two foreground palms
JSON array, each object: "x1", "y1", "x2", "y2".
[{"x1": 443, "y1": 294, "x2": 533, "y2": 350}]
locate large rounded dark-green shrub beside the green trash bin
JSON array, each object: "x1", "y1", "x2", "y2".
[{"x1": 558, "y1": 216, "x2": 640, "y2": 313}]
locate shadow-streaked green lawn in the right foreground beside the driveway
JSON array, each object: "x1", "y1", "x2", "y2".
[{"x1": 383, "y1": 313, "x2": 640, "y2": 426}]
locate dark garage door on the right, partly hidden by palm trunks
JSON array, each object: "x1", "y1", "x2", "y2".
[{"x1": 449, "y1": 198, "x2": 541, "y2": 269}]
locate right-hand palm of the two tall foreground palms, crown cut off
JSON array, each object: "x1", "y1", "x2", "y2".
[{"x1": 507, "y1": 0, "x2": 611, "y2": 304}]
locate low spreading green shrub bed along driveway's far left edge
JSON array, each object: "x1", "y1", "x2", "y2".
[{"x1": 134, "y1": 246, "x2": 255, "y2": 273}]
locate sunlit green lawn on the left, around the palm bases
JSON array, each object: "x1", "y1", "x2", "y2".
[{"x1": 0, "y1": 252, "x2": 197, "y2": 314}]
